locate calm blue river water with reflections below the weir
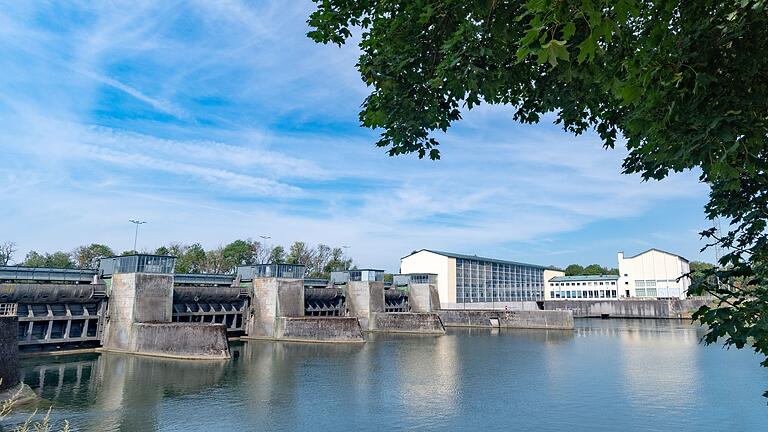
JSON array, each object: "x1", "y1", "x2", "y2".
[{"x1": 4, "y1": 320, "x2": 768, "y2": 432}]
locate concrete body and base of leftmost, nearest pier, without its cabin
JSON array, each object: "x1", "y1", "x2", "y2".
[{"x1": 102, "y1": 273, "x2": 229, "y2": 359}]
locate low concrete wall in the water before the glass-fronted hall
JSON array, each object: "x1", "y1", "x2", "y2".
[{"x1": 437, "y1": 309, "x2": 573, "y2": 330}]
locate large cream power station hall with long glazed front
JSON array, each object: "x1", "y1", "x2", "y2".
[{"x1": 400, "y1": 249, "x2": 565, "y2": 310}]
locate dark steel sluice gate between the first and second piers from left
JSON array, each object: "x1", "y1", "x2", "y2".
[{"x1": 172, "y1": 274, "x2": 248, "y2": 334}]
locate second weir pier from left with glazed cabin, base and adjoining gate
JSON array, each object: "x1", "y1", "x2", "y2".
[{"x1": 237, "y1": 264, "x2": 365, "y2": 343}]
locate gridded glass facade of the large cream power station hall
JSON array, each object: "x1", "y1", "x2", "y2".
[{"x1": 456, "y1": 258, "x2": 544, "y2": 303}]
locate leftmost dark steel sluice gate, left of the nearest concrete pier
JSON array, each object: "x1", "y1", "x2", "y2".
[{"x1": 0, "y1": 266, "x2": 107, "y2": 352}]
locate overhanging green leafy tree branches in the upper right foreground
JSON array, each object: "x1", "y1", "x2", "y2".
[{"x1": 309, "y1": 0, "x2": 768, "y2": 392}]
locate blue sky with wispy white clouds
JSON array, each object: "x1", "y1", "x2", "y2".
[{"x1": 0, "y1": 0, "x2": 714, "y2": 271}]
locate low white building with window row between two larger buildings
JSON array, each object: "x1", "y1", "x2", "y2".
[{"x1": 544, "y1": 275, "x2": 621, "y2": 300}]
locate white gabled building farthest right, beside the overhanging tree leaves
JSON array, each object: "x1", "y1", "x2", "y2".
[{"x1": 618, "y1": 249, "x2": 691, "y2": 299}]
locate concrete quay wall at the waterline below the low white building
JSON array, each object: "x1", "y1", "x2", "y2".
[{"x1": 544, "y1": 299, "x2": 711, "y2": 319}]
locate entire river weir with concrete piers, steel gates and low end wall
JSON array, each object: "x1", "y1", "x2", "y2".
[{"x1": 0, "y1": 254, "x2": 573, "y2": 386}]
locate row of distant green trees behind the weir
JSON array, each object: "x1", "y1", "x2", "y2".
[{"x1": 0, "y1": 239, "x2": 354, "y2": 278}]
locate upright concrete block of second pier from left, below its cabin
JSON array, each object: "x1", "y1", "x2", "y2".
[{"x1": 246, "y1": 278, "x2": 304, "y2": 339}]
